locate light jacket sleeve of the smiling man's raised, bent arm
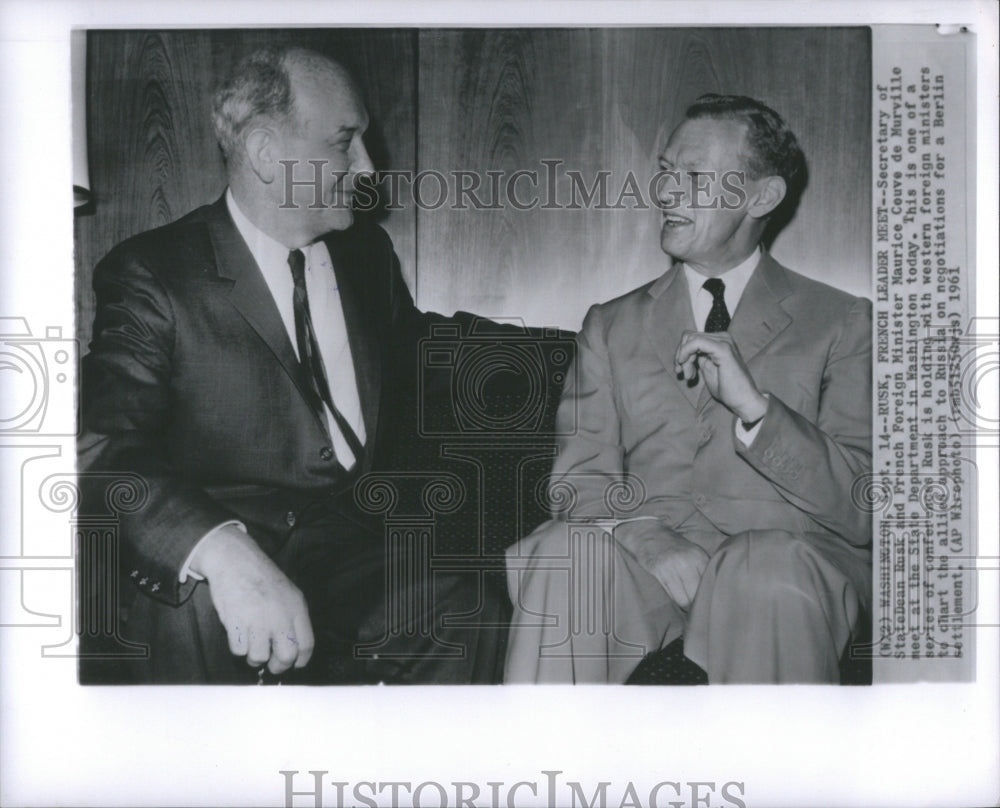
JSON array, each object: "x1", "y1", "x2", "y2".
[{"x1": 735, "y1": 299, "x2": 872, "y2": 546}]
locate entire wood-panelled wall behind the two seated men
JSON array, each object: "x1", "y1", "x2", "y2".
[{"x1": 76, "y1": 28, "x2": 870, "y2": 345}]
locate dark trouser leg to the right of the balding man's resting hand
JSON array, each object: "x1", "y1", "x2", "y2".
[{"x1": 288, "y1": 508, "x2": 508, "y2": 684}]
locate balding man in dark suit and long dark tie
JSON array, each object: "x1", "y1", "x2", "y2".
[{"x1": 79, "y1": 48, "x2": 502, "y2": 684}]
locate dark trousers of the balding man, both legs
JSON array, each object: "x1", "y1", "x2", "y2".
[{"x1": 97, "y1": 504, "x2": 509, "y2": 684}]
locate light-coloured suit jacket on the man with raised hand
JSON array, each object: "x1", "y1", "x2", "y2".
[{"x1": 552, "y1": 253, "x2": 872, "y2": 560}]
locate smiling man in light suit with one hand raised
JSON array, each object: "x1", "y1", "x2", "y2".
[{"x1": 506, "y1": 95, "x2": 871, "y2": 683}]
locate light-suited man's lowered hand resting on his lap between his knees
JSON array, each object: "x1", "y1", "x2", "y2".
[{"x1": 615, "y1": 519, "x2": 708, "y2": 609}]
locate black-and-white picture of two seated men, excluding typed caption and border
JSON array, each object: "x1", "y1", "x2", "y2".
[{"x1": 76, "y1": 28, "x2": 872, "y2": 684}]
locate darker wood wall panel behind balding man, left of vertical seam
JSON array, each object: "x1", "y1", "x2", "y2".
[{"x1": 75, "y1": 29, "x2": 416, "y2": 346}]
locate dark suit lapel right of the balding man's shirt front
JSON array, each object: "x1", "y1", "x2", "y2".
[{"x1": 323, "y1": 232, "x2": 382, "y2": 462}]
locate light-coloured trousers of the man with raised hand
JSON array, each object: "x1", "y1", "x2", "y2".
[{"x1": 504, "y1": 521, "x2": 871, "y2": 684}]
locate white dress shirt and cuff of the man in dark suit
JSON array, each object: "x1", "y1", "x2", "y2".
[{"x1": 179, "y1": 190, "x2": 366, "y2": 583}]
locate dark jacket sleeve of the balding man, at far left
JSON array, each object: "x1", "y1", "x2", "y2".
[{"x1": 78, "y1": 247, "x2": 233, "y2": 603}]
